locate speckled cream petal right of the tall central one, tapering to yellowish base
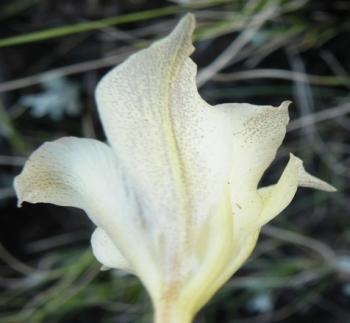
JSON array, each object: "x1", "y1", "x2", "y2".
[{"x1": 186, "y1": 101, "x2": 290, "y2": 307}]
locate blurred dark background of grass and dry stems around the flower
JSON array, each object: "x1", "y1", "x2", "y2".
[{"x1": 0, "y1": 0, "x2": 350, "y2": 323}]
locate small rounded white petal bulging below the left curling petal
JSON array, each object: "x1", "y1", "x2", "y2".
[{"x1": 91, "y1": 228, "x2": 132, "y2": 272}]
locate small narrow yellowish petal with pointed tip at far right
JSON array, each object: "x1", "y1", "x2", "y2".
[{"x1": 259, "y1": 154, "x2": 336, "y2": 225}]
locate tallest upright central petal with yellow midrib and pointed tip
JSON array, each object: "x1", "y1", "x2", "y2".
[{"x1": 96, "y1": 15, "x2": 234, "y2": 278}]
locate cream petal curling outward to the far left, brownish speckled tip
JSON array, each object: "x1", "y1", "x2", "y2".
[{"x1": 15, "y1": 137, "x2": 157, "y2": 292}]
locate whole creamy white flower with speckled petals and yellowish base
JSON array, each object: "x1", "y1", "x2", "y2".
[{"x1": 15, "y1": 14, "x2": 334, "y2": 323}]
